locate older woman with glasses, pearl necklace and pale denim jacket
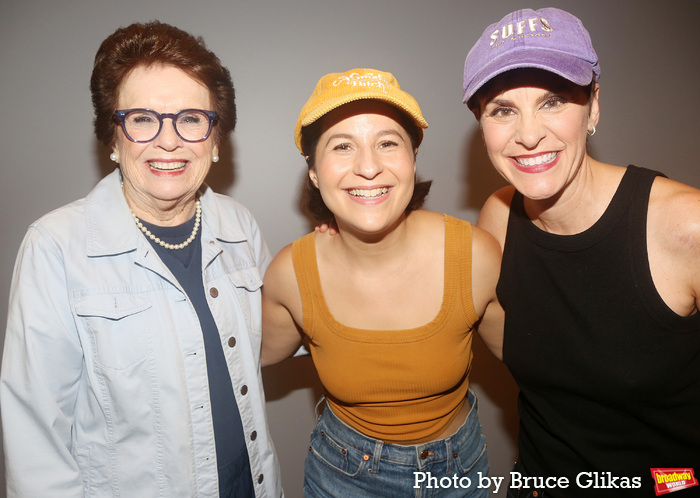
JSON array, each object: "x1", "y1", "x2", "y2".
[{"x1": 0, "y1": 22, "x2": 281, "y2": 497}]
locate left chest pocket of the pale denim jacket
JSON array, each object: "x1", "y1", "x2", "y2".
[{"x1": 75, "y1": 293, "x2": 153, "y2": 370}]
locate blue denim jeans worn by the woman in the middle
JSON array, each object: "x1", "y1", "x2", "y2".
[{"x1": 304, "y1": 391, "x2": 489, "y2": 498}]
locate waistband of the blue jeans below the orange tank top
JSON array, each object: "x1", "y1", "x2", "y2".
[{"x1": 316, "y1": 390, "x2": 481, "y2": 471}]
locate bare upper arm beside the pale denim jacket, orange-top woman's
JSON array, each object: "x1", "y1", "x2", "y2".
[{"x1": 262, "y1": 245, "x2": 302, "y2": 366}]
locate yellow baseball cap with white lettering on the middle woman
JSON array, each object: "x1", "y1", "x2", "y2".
[{"x1": 294, "y1": 69, "x2": 428, "y2": 154}]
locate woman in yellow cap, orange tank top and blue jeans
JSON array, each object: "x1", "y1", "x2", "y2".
[{"x1": 263, "y1": 69, "x2": 500, "y2": 497}]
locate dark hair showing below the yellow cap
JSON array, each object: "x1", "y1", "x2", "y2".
[{"x1": 301, "y1": 102, "x2": 433, "y2": 223}]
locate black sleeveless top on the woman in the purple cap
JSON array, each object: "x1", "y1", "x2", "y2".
[{"x1": 497, "y1": 166, "x2": 700, "y2": 497}]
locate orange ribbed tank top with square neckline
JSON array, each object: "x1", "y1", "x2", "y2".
[{"x1": 292, "y1": 215, "x2": 478, "y2": 444}]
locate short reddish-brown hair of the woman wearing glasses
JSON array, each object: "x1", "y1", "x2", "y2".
[{"x1": 90, "y1": 21, "x2": 236, "y2": 147}]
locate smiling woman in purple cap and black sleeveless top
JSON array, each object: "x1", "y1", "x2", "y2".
[{"x1": 464, "y1": 4, "x2": 700, "y2": 497}]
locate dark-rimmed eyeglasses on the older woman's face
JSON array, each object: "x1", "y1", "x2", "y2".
[{"x1": 114, "y1": 109, "x2": 216, "y2": 143}]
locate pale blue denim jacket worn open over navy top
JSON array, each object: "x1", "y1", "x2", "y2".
[{"x1": 0, "y1": 170, "x2": 282, "y2": 498}]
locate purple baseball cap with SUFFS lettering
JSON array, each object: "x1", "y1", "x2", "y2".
[{"x1": 463, "y1": 8, "x2": 600, "y2": 103}]
